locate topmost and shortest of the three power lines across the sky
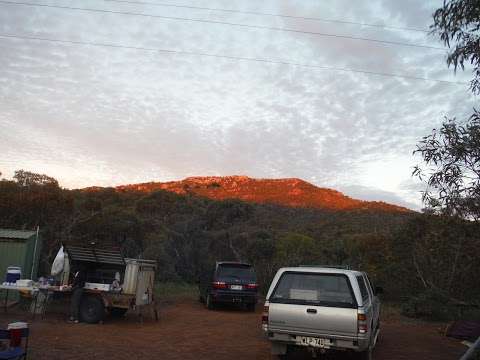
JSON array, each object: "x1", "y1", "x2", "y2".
[{"x1": 101, "y1": 0, "x2": 429, "y2": 33}]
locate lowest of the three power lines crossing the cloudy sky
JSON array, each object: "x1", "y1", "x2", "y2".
[{"x1": 0, "y1": 33, "x2": 469, "y2": 85}]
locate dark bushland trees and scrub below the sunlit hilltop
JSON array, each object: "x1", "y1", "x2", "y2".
[{"x1": 0, "y1": 171, "x2": 480, "y2": 318}]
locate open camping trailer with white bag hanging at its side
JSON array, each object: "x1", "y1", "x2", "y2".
[{"x1": 52, "y1": 245, "x2": 158, "y2": 323}]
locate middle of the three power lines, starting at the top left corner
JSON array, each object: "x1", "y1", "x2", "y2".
[{"x1": 0, "y1": 0, "x2": 445, "y2": 51}]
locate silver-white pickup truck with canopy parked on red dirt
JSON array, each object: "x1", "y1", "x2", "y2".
[{"x1": 262, "y1": 266, "x2": 381, "y2": 359}]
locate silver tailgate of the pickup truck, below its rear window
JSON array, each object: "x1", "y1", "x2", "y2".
[{"x1": 268, "y1": 303, "x2": 357, "y2": 337}]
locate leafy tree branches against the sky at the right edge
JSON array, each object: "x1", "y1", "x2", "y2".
[{"x1": 413, "y1": 0, "x2": 480, "y2": 220}]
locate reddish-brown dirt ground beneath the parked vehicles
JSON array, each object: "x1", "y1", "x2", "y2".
[{"x1": 0, "y1": 300, "x2": 466, "y2": 360}]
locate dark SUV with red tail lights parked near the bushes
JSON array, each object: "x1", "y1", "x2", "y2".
[{"x1": 199, "y1": 261, "x2": 258, "y2": 311}]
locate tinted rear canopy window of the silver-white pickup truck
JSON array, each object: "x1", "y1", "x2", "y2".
[{"x1": 270, "y1": 272, "x2": 356, "y2": 308}]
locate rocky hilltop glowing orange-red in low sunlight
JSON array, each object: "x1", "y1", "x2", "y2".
[{"x1": 117, "y1": 176, "x2": 411, "y2": 212}]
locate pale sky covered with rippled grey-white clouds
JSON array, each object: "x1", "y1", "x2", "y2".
[{"x1": 0, "y1": 0, "x2": 475, "y2": 209}]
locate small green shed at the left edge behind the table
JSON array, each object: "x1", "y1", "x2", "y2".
[{"x1": 0, "y1": 229, "x2": 42, "y2": 283}]
